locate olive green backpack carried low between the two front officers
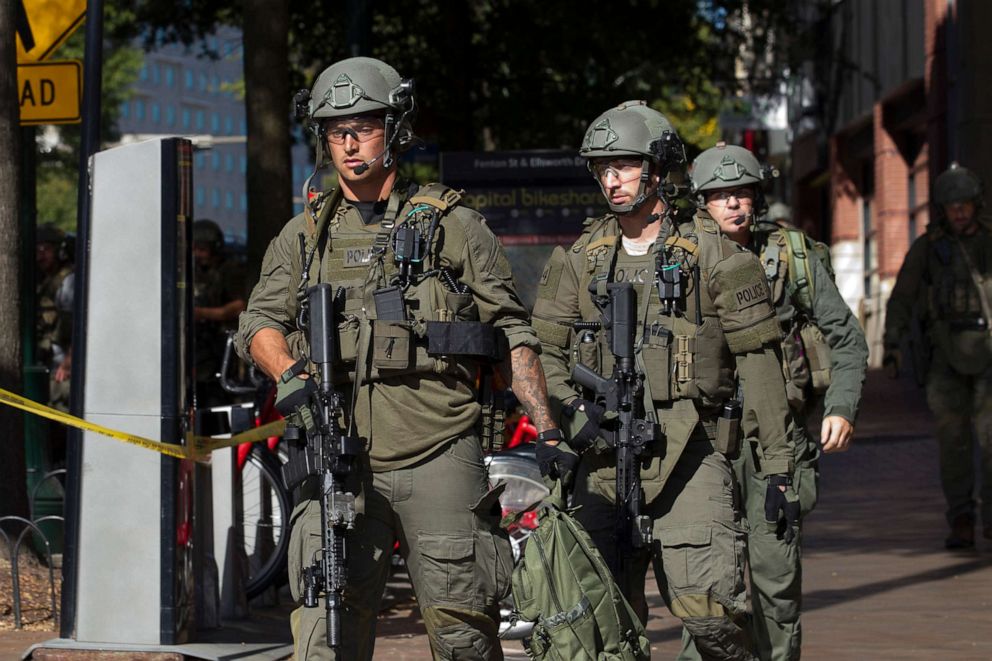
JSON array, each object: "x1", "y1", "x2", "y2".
[{"x1": 512, "y1": 485, "x2": 651, "y2": 661}]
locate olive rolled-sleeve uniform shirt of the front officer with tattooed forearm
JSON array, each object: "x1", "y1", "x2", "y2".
[{"x1": 238, "y1": 186, "x2": 540, "y2": 472}]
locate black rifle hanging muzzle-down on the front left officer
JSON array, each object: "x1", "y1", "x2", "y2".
[{"x1": 282, "y1": 283, "x2": 363, "y2": 653}]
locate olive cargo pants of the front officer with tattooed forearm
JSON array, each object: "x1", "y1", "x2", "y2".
[{"x1": 289, "y1": 436, "x2": 513, "y2": 661}]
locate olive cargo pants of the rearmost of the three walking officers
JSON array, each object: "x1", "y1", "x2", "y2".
[{"x1": 679, "y1": 414, "x2": 820, "y2": 661}]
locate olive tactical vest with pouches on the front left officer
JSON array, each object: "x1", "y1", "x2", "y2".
[{"x1": 286, "y1": 184, "x2": 506, "y2": 384}]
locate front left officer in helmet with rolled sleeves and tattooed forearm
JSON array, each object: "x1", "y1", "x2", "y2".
[{"x1": 238, "y1": 57, "x2": 560, "y2": 661}]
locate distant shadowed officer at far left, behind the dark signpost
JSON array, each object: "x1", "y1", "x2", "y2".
[{"x1": 35, "y1": 223, "x2": 75, "y2": 411}]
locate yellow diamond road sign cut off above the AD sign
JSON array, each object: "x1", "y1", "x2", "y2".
[{"x1": 15, "y1": 0, "x2": 86, "y2": 64}]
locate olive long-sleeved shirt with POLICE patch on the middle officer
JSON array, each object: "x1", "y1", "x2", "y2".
[{"x1": 534, "y1": 215, "x2": 792, "y2": 480}]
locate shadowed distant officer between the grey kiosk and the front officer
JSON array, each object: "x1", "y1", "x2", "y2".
[{"x1": 193, "y1": 218, "x2": 248, "y2": 407}]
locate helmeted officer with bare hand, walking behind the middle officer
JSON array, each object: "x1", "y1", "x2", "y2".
[{"x1": 682, "y1": 143, "x2": 868, "y2": 661}]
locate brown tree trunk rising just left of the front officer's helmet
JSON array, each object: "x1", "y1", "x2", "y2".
[{"x1": 244, "y1": 0, "x2": 293, "y2": 279}]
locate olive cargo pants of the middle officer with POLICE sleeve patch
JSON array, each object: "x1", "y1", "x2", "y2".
[{"x1": 573, "y1": 439, "x2": 753, "y2": 659}]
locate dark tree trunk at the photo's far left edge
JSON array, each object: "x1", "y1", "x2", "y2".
[{"x1": 0, "y1": 2, "x2": 31, "y2": 516}]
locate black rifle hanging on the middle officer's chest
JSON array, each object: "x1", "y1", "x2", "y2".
[{"x1": 572, "y1": 282, "x2": 662, "y2": 596}]
